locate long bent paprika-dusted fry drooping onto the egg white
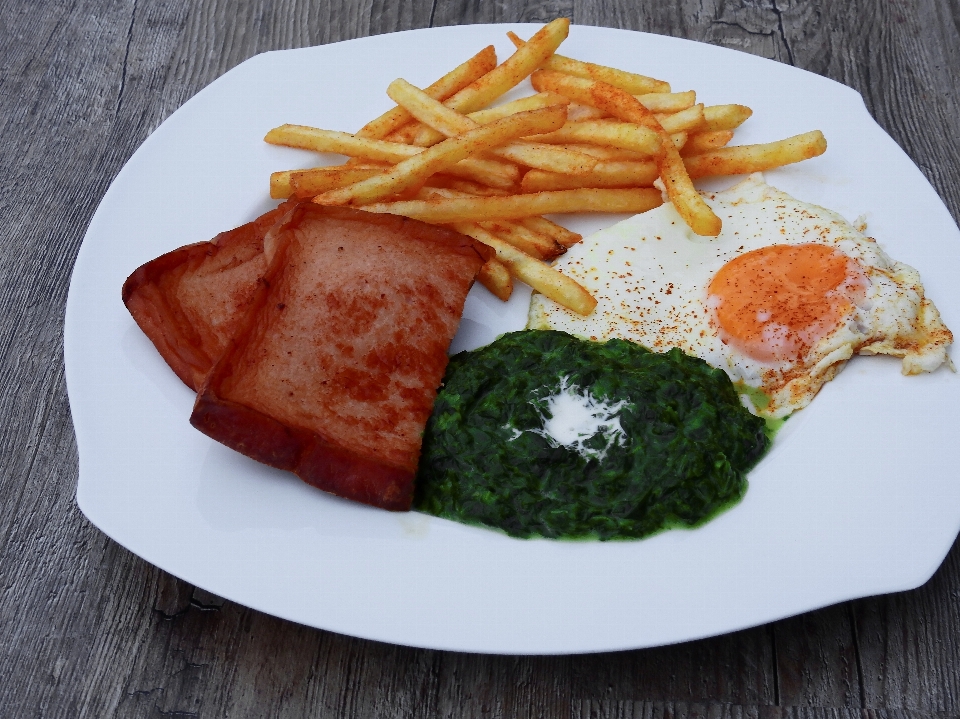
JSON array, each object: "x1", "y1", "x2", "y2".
[{"x1": 530, "y1": 70, "x2": 722, "y2": 237}]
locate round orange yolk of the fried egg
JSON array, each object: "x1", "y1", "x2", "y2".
[{"x1": 708, "y1": 244, "x2": 867, "y2": 362}]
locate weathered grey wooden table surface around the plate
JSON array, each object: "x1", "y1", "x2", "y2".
[{"x1": 0, "y1": 0, "x2": 960, "y2": 717}]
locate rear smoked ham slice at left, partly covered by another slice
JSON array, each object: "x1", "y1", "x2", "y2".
[{"x1": 122, "y1": 205, "x2": 288, "y2": 391}]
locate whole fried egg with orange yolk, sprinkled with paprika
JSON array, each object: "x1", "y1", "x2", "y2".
[{"x1": 528, "y1": 174, "x2": 953, "y2": 418}]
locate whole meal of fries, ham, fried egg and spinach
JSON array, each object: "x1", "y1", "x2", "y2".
[{"x1": 123, "y1": 19, "x2": 952, "y2": 539}]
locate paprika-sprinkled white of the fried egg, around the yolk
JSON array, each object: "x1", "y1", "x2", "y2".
[{"x1": 528, "y1": 174, "x2": 952, "y2": 418}]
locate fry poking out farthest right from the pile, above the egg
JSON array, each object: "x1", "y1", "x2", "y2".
[{"x1": 684, "y1": 130, "x2": 827, "y2": 177}]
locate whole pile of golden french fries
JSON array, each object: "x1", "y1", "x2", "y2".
[{"x1": 264, "y1": 18, "x2": 827, "y2": 315}]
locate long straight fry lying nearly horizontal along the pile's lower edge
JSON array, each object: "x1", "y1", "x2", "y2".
[{"x1": 363, "y1": 188, "x2": 663, "y2": 224}]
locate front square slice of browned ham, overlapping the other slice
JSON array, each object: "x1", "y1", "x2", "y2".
[{"x1": 188, "y1": 202, "x2": 492, "y2": 510}]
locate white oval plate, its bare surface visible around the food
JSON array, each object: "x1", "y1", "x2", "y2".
[{"x1": 64, "y1": 26, "x2": 960, "y2": 653}]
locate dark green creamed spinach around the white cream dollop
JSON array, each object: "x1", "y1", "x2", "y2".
[{"x1": 414, "y1": 330, "x2": 770, "y2": 540}]
